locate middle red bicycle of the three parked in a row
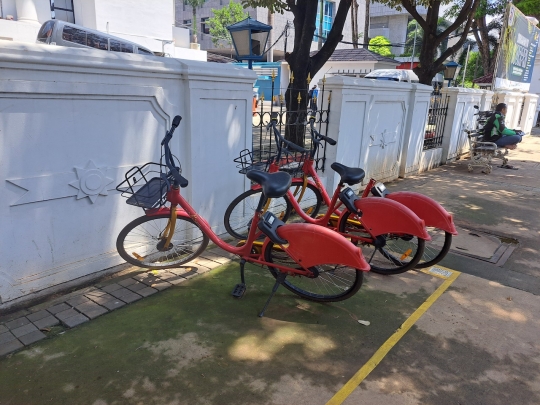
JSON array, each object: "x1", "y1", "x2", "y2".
[{"x1": 225, "y1": 117, "x2": 430, "y2": 274}]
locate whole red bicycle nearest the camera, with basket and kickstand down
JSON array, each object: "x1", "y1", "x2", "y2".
[{"x1": 116, "y1": 116, "x2": 370, "y2": 316}]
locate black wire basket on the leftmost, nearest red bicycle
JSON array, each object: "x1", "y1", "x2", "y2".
[{"x1": 116, "y1": 163, "x2": 173, "y2": 209}]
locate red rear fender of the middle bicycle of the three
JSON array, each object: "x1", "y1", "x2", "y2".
[{"x1": 346, "y1": 197, "x2": 431, "y2": 240}]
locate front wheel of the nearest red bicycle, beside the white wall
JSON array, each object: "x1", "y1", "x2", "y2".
[{"x1": 116, "y1": 214, "x2": 208, "y2": 269}]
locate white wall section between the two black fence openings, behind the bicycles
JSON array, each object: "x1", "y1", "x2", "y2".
[{"x1": 325, "y1": 76, "x2": 432, "y2": 191}]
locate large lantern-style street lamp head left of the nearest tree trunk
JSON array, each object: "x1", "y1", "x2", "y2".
[{"x1": 227, "y1": 17, "x2": 272, "y2": 69}]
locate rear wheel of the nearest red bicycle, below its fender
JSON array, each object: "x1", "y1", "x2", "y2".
[{"x1": 264, "y1": 242, "x2": 364, "y2": 302}]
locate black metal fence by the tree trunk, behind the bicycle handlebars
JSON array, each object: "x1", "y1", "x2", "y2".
[{"x1": 252, "y1": 76, "x2": 332, "y2": 172}]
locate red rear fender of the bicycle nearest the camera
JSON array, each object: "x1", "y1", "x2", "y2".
[{"x1": 263, "y1": 224, "x2": 370, "y2": 271}]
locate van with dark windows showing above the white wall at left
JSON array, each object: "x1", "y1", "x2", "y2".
[{"x1": 36, "y1": 20, "x2": 154, "y2": 56}]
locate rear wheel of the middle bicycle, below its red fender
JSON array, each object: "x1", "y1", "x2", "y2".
[{"x1": 338, "y1": 211, "x2": 425, "y2": 275}]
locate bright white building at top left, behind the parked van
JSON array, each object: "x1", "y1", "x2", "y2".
[{"x1": 0, "y1": 0, "x2": 206, "y2": 60}]
